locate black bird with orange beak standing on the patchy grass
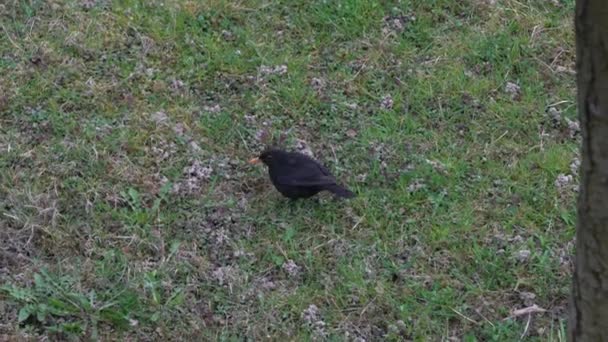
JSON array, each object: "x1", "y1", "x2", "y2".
[{"x1": 249, "y1": 148, "x2": 355, "y2": 199}]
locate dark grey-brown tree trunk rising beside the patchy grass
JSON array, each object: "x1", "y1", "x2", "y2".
[{"x1": 568, "y1": 0, "x2": 608, "y2": 341}]
